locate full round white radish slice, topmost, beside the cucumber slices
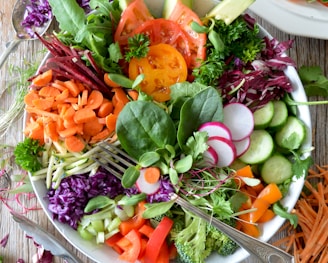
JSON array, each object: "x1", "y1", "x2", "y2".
[{"x1": 223, "y1": 102, "x2": 254, "y2": 141}]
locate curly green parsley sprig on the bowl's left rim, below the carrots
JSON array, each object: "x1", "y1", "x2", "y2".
[{"x1": 14, "y1": 138, "x2": 44, "y2": 173}]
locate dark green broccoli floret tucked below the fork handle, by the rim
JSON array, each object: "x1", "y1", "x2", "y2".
[{"x1": 206, "y1": 225, "x2": 239, "y2": 256}]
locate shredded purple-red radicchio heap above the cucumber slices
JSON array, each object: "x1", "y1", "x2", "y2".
[{"x1": 218, "y1": 37, "x2": 296, "y2": 111}]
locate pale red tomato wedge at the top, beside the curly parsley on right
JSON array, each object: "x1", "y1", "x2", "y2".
[{"x1": 169, "y1": 1, "x2": 207, "y2": 68}]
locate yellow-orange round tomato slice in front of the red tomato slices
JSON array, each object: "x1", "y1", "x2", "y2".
[{"x1": 129, "y1": 43, "x2": 188, "y2": 102}]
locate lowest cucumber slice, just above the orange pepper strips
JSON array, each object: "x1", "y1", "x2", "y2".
[{"x1": 261, "y1": 154, "x2": 293, "y2": 184}]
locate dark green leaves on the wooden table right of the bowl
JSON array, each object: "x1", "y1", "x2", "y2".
[{"x1": 298, "y1": 66, "x2": 328, "y2": 97}]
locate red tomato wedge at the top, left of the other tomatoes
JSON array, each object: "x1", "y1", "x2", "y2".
[{"x1": 114, "y1": 0, "x2": 154, "y2": 46}]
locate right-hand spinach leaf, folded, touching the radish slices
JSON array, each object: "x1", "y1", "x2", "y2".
[{"x1": 177, "y1": 87, "x2": 223, "y2": 149}]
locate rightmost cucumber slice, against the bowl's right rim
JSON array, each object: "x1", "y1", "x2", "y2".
[{"x1": 275, "y1": 116, "x2": 306, "y2": 150}]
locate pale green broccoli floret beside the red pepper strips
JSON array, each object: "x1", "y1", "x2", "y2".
[{"x1": 174, "y1": 213, "x2": 210, "y2": 263}]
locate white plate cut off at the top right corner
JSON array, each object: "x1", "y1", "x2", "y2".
[{"x1": 249, "y1": 0, "x2": 328, "y2": 39}]
